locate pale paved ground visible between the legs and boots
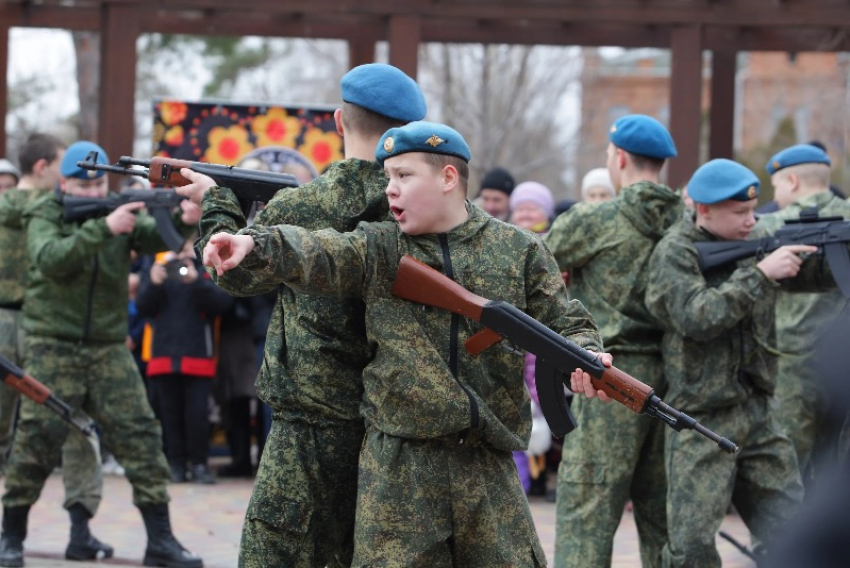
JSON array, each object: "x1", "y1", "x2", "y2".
[{"x1": 4, "y1": 466, "x2": 754, "y2": 568}]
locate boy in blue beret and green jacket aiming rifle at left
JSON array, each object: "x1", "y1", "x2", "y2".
[{"x1": 0, "y1": 142, "x2": 203, "y2": 568}]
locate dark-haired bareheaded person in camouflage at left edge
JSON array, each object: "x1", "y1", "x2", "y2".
[{"x1": 0, "y1": 133, "x2": 113, "y2": 560}]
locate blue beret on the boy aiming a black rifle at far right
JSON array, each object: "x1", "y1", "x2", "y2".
[{"x1": 688, "y1": 158, "x2": 759, "y2": 205}]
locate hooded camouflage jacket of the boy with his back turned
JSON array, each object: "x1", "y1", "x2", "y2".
[{"x1": 545, "y1": 181, "x2": 683, "y2": 352}]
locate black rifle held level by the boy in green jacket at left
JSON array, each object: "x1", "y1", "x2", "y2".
[{"x1": 62, "y1": 189, "x2": 186, "y2": 252}]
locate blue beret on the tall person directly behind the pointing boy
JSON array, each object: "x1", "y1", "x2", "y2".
[{"x1": 340, "y1": 63, "x2": 427, "y2": 122}]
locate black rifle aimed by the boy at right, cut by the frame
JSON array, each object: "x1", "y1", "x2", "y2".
[{"x1": 694, "y1": 213, "x2": 850, "y2": 298}]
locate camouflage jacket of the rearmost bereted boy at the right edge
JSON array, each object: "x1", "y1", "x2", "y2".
[{"x1": 758, "y1": 191, "x2": 850, "y2": 358}]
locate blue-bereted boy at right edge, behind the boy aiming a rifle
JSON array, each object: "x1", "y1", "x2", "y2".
[{"x1": 758, "y1": 144, "x2": 850, "y2": 483}]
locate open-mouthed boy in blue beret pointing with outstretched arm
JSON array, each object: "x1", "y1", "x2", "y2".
[{"x1": 204, "y1": 122, "x2": 610, "y2": 568}]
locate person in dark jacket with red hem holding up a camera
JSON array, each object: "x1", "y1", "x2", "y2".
[{"x1": 136, "y1": 239, "x2": 233, "y2": 483}]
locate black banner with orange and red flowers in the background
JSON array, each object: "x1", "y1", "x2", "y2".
[{"x1": 153, "y1": 100, "x2": 343, "y2": 183}]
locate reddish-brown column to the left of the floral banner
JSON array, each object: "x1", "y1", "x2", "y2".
[{"x1": 98, "y1": 3, "x2": 139, "y2": 161}]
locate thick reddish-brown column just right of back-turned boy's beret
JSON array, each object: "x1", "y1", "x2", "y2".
[{"x1": 667, "y1": 26, "x2": 702, "y2": 188}]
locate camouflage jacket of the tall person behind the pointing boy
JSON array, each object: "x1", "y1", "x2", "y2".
[{"x1": 199, "y1": 159, "x2": 389, "y2": 425}]
